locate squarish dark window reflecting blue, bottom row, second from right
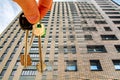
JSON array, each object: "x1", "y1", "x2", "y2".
[{"x1": 90, "y1": 60, "x2": 102, "y2": 71}]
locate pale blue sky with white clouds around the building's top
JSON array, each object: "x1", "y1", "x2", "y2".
[{"x1": 0, "y1": 0, "x2": 120, "y2": 33}]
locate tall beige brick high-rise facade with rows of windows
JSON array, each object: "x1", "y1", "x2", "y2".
[{"x1": 0, "y1": 0, "x2": 120, "y2": 80}]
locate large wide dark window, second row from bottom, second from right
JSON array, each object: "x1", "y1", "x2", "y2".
[{"x1": 87, "y1": 45, "x2": 107, "y2": 53}]
